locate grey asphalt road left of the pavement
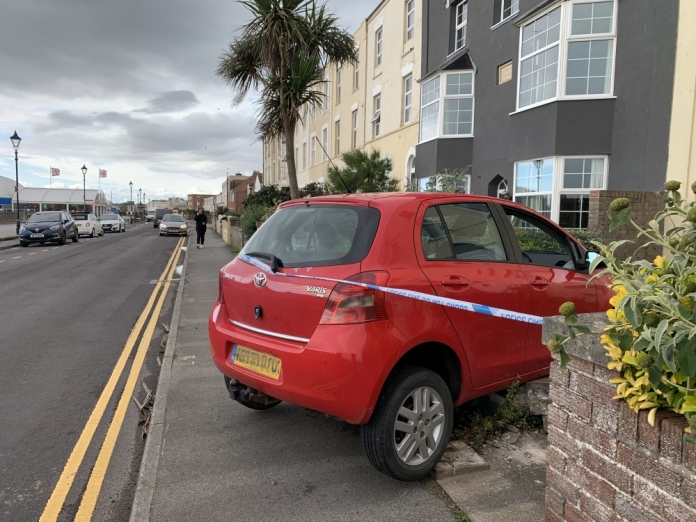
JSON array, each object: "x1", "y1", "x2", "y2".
[{"x1": 0, "y1": 224, "x2": 181, "y2": 521}]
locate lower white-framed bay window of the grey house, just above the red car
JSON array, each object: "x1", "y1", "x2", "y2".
[{"x1": 513, "y1": 156, "x2": 609, "y2": 228}]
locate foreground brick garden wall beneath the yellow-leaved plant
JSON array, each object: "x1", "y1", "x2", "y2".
[{"x1": 543, "y1": 314, "x2": 696, "y2": 522}]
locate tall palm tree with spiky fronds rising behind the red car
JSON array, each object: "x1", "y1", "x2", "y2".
[{"x1": 216, "y1": 0, "x2": 357, "y2": 199}]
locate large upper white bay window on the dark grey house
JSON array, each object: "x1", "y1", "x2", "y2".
[{"x1": 517, "y1": 0, "x2": 617, "y2": 110}]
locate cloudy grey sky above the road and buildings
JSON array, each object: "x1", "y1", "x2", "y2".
[{"x1": 0, "y1": 0, "x2": 379, "y2": 202}]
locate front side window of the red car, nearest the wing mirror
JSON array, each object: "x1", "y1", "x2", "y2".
[{"x1": 505, "y1": 208, "x2": 575, "y2": 270}]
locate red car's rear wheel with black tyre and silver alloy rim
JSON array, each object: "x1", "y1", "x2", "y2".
[{"x1": 360, "y1": 366, "x2": 454, "y2": 482}]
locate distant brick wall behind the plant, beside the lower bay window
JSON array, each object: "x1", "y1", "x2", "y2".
[{"x1": 587, "y1": 190, "x2": 664, "y2": 261}]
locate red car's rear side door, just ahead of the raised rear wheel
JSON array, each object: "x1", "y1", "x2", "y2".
[{"x1": 416, "y1": 198, "x2": 530, "y2": 388}]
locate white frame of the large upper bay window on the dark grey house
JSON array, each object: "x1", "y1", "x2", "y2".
[{"x1": 511, "y1": 0, "x2": 619, "y2": 114}]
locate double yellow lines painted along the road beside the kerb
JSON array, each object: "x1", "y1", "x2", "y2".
[{"x1": 39, "y1": 237, "x2": 186, "y2": 522}]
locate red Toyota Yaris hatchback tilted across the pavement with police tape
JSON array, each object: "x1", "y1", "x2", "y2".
[{"x1": 209, "y1": 193, "x2": 611, "y2": 480}]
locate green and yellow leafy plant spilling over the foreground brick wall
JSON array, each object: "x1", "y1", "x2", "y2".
[{"x1": 548, "y1": 181, "x2": 696, "y2": 442}]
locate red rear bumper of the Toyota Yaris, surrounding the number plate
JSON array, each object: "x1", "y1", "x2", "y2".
[{"x1": 208, "y1": 301, "x2": 405, "y2": 424}]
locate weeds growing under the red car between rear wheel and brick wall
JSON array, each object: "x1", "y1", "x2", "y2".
[{"x1": 453, "y1": 381, "x2": 543, "y2": 447}]
